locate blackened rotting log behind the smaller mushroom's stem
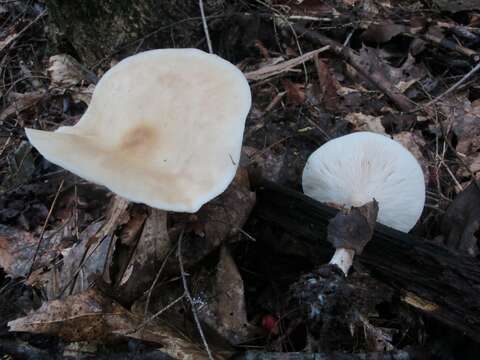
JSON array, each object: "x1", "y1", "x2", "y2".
[{"x1": 256, "y1": 182, "x2": 480, "y2": 342}]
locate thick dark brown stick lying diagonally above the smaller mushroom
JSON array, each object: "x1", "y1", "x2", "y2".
[{"x1": 292, "y1": 24, "x2": 414, "y2": 111}]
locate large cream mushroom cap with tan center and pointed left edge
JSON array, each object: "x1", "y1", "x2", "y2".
[{"x1": 26, "y1": 49, "x2": 251, "y2": 212}]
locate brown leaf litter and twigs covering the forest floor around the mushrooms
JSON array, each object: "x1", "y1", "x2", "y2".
[{"x1": 0, "y1": 0, "x2": 480, "y2": 359}]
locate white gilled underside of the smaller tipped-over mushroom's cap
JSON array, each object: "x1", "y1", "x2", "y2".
[{"x1": 302, "y1": 132, "x2": 425, "y2": 232}]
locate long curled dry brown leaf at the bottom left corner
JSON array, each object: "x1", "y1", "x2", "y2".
[{"x1": 8, "y1": 289, "x2": 219, "y2": 360}]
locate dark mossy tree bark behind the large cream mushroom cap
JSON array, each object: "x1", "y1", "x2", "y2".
[{"x1": 46, "y1": 0, "x2": 225, "y2": 67}]
